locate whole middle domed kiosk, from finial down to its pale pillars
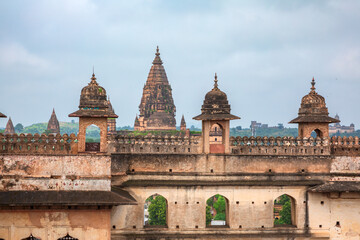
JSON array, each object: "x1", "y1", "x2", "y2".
[{"x1": 193, "y1": 73, "x2": 240, "y2": 153}]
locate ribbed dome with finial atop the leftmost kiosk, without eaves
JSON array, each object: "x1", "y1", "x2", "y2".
[{"x1": 79, "y1": 74, "x2": 108, "y2": 108}]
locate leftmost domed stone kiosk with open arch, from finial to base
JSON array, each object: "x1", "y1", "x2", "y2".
[{"x1": 69, "y1": 73, "x2": 118, "y2": 152}]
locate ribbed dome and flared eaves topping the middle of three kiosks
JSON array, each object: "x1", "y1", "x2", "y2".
[{"x1": 194, "y1": 74, "x2": 239, "y2": 120}]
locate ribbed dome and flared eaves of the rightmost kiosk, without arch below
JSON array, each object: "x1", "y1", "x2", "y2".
[{"x1": 290, "y1": 78, "x2": 339, "y2": 123}]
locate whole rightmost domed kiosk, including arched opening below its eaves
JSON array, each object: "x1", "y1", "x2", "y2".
[{"x1": 289, "y1": 78, "x2": 340, "y2": 138}]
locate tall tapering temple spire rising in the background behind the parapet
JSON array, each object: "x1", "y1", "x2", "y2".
[{"x1": 134, "y1": 47, "x2": 176, "y2": 131}]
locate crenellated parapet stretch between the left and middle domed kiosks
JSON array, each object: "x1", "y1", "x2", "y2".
[{"x1": 108, "y1": 135, "x2": 201, "y2": 154}]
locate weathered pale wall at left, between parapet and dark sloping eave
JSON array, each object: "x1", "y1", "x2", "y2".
[{"x1": 0, "y1": 155, "x2": 111, "y2": 191}]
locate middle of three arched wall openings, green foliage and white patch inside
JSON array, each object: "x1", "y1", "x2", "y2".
[{"x1": 206, "y1": 194, "x2": 229, "y2": 227}]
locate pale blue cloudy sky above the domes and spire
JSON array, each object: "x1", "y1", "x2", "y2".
[{"x1": 0, "y1": 0, "x2": 360, "y2": 129}]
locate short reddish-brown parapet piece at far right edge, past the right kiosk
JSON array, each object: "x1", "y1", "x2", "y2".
[{"x1": 330, "y1": 136, "x2": 360, "y2": 156}]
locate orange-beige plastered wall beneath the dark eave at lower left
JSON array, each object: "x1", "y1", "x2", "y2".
[{"x1": 0, "y1": 209, "x2": 110, "y2": 240}]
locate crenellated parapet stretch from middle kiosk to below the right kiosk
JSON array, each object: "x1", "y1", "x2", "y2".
[{"x1": 230, "y1": 136, "x2": 330, "y2": 155}]
